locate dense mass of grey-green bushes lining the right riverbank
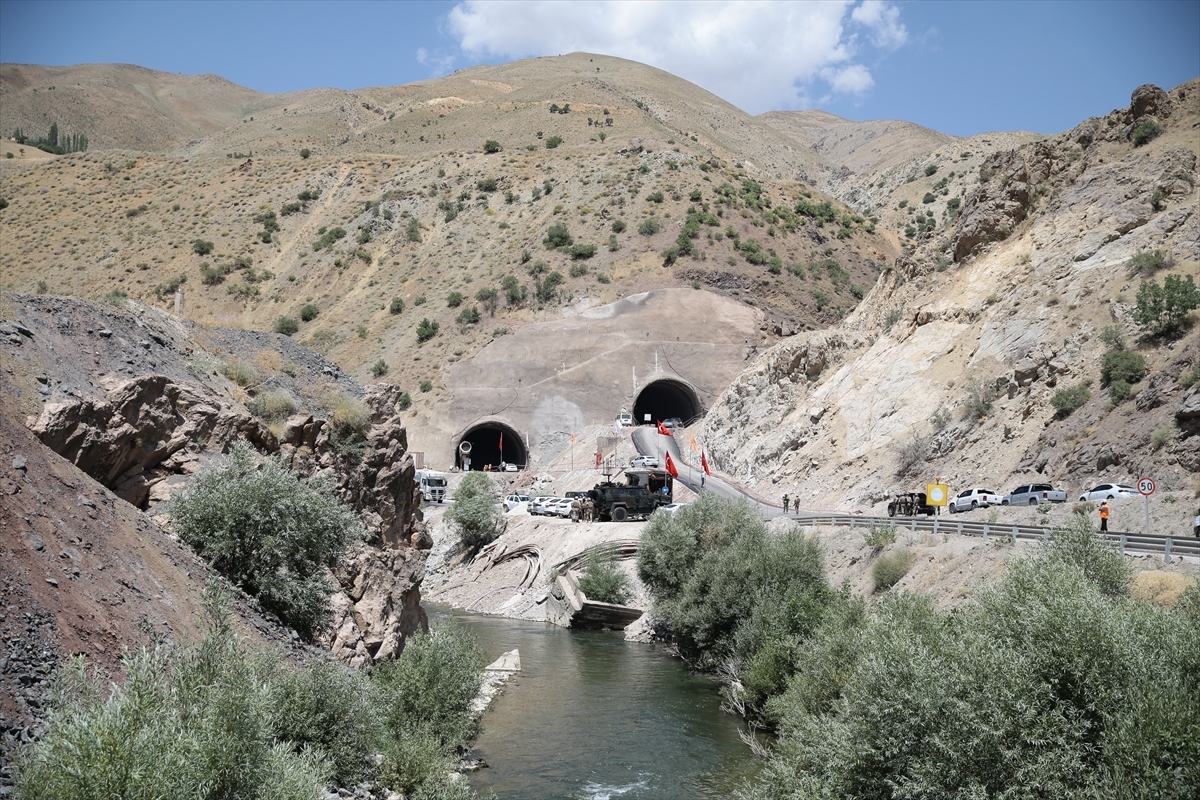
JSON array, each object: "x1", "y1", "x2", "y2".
[{"x1": 638, "y1": 498, "x2": 1200, "y2": 800}]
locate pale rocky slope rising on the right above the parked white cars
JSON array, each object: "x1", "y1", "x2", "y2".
[{"x1": 702, "y1": 82, "x2": 1200, "y2": 533}]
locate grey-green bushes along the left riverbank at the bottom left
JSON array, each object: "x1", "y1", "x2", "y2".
[{"x1": 16, "y1": 584, "x2": 484, "y2": 800}]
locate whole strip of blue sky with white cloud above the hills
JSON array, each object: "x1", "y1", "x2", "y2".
[{"x1": 0, "y1": 0, "x2": 1200, "y2": 136}]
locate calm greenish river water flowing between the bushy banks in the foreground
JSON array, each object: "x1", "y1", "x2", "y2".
[{"x1": 430, "y1": 608, "x2": 757, "y2": 800}]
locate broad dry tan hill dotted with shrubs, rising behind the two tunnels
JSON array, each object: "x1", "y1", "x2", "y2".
[{"x1": 0, "y1": 54, "x2": 898, "y2": 405}]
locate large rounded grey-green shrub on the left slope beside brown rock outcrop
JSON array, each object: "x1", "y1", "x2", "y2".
[{"x1": 172, "y1": 444, "x2": 361, "y2": 639}]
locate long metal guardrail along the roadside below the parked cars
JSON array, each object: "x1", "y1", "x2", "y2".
[{"x1": 792, "y1": 515, "x2": 1200, "y2": 561}]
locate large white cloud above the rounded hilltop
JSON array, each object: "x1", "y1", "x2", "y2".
[{"x1": 446, "y1": 0, "x2": 907, "y2": 114}]
